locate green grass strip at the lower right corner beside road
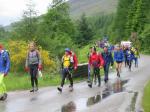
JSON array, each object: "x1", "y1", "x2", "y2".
[{"x1": 142, "y1": 82, "x2": 150, "y2": 112}]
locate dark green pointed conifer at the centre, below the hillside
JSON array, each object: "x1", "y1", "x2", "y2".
[{"x1": 75, "y1": 14, "x2": 93, "y2": 45}]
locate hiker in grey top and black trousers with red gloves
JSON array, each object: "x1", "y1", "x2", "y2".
[{"x1": 25, "y1": 42, "x2": 42, "y2": 92}]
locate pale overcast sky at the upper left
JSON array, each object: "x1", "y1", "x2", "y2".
[{"x1": 0, "y1": 0, "x2": 52, "y2": 26}]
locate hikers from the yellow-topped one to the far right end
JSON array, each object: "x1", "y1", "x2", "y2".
[{"x1": 57, "y1": 45, "x2": 140, "y2": 92}]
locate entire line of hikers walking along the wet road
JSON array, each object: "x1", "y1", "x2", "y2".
[{"x1": 0, "y1": 42, "x2": 139, "y2": 100}]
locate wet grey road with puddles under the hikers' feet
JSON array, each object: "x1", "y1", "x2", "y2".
[{"x1": 0, "y1": 56, "x2": 150, "y2": 112}]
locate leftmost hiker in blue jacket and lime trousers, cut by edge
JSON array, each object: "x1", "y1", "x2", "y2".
[{"x1": 0, "y1": 44, "x2": 10, "y2": 101}]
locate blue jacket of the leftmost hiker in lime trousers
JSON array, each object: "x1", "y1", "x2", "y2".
[{"x1": 0, "y1": 50, "x2": 10, "y2": 74}]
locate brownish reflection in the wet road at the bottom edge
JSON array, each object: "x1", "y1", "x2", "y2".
[{"x1": 61, "y1": 102, "x2": 76, "y2": 112}]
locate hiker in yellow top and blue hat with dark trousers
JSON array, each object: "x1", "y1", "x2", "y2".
[{"x1": 57, "y1": 48, "x2": 73, "y2": 92}]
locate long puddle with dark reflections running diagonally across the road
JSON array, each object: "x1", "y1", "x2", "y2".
[{"x1": 60, "y1": 78, "x2": 128, "y2": 112}]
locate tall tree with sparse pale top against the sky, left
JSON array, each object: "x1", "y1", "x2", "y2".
[{"x1": 12, "y1": 0, "x2": 38, "y2": 40}]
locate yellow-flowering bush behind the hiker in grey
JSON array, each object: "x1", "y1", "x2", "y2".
[{"x1": 7, "y1": 41, "x2": 56, "y2": 72}]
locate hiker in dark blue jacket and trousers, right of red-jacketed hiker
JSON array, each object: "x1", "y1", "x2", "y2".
[{"x1": 102, "y1": 46, "x2": 114, "y2": 83}]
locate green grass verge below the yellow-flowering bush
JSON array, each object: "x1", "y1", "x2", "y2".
[{"x1": 4, "y1": 73, "x2": 60, "y2": 91}]
